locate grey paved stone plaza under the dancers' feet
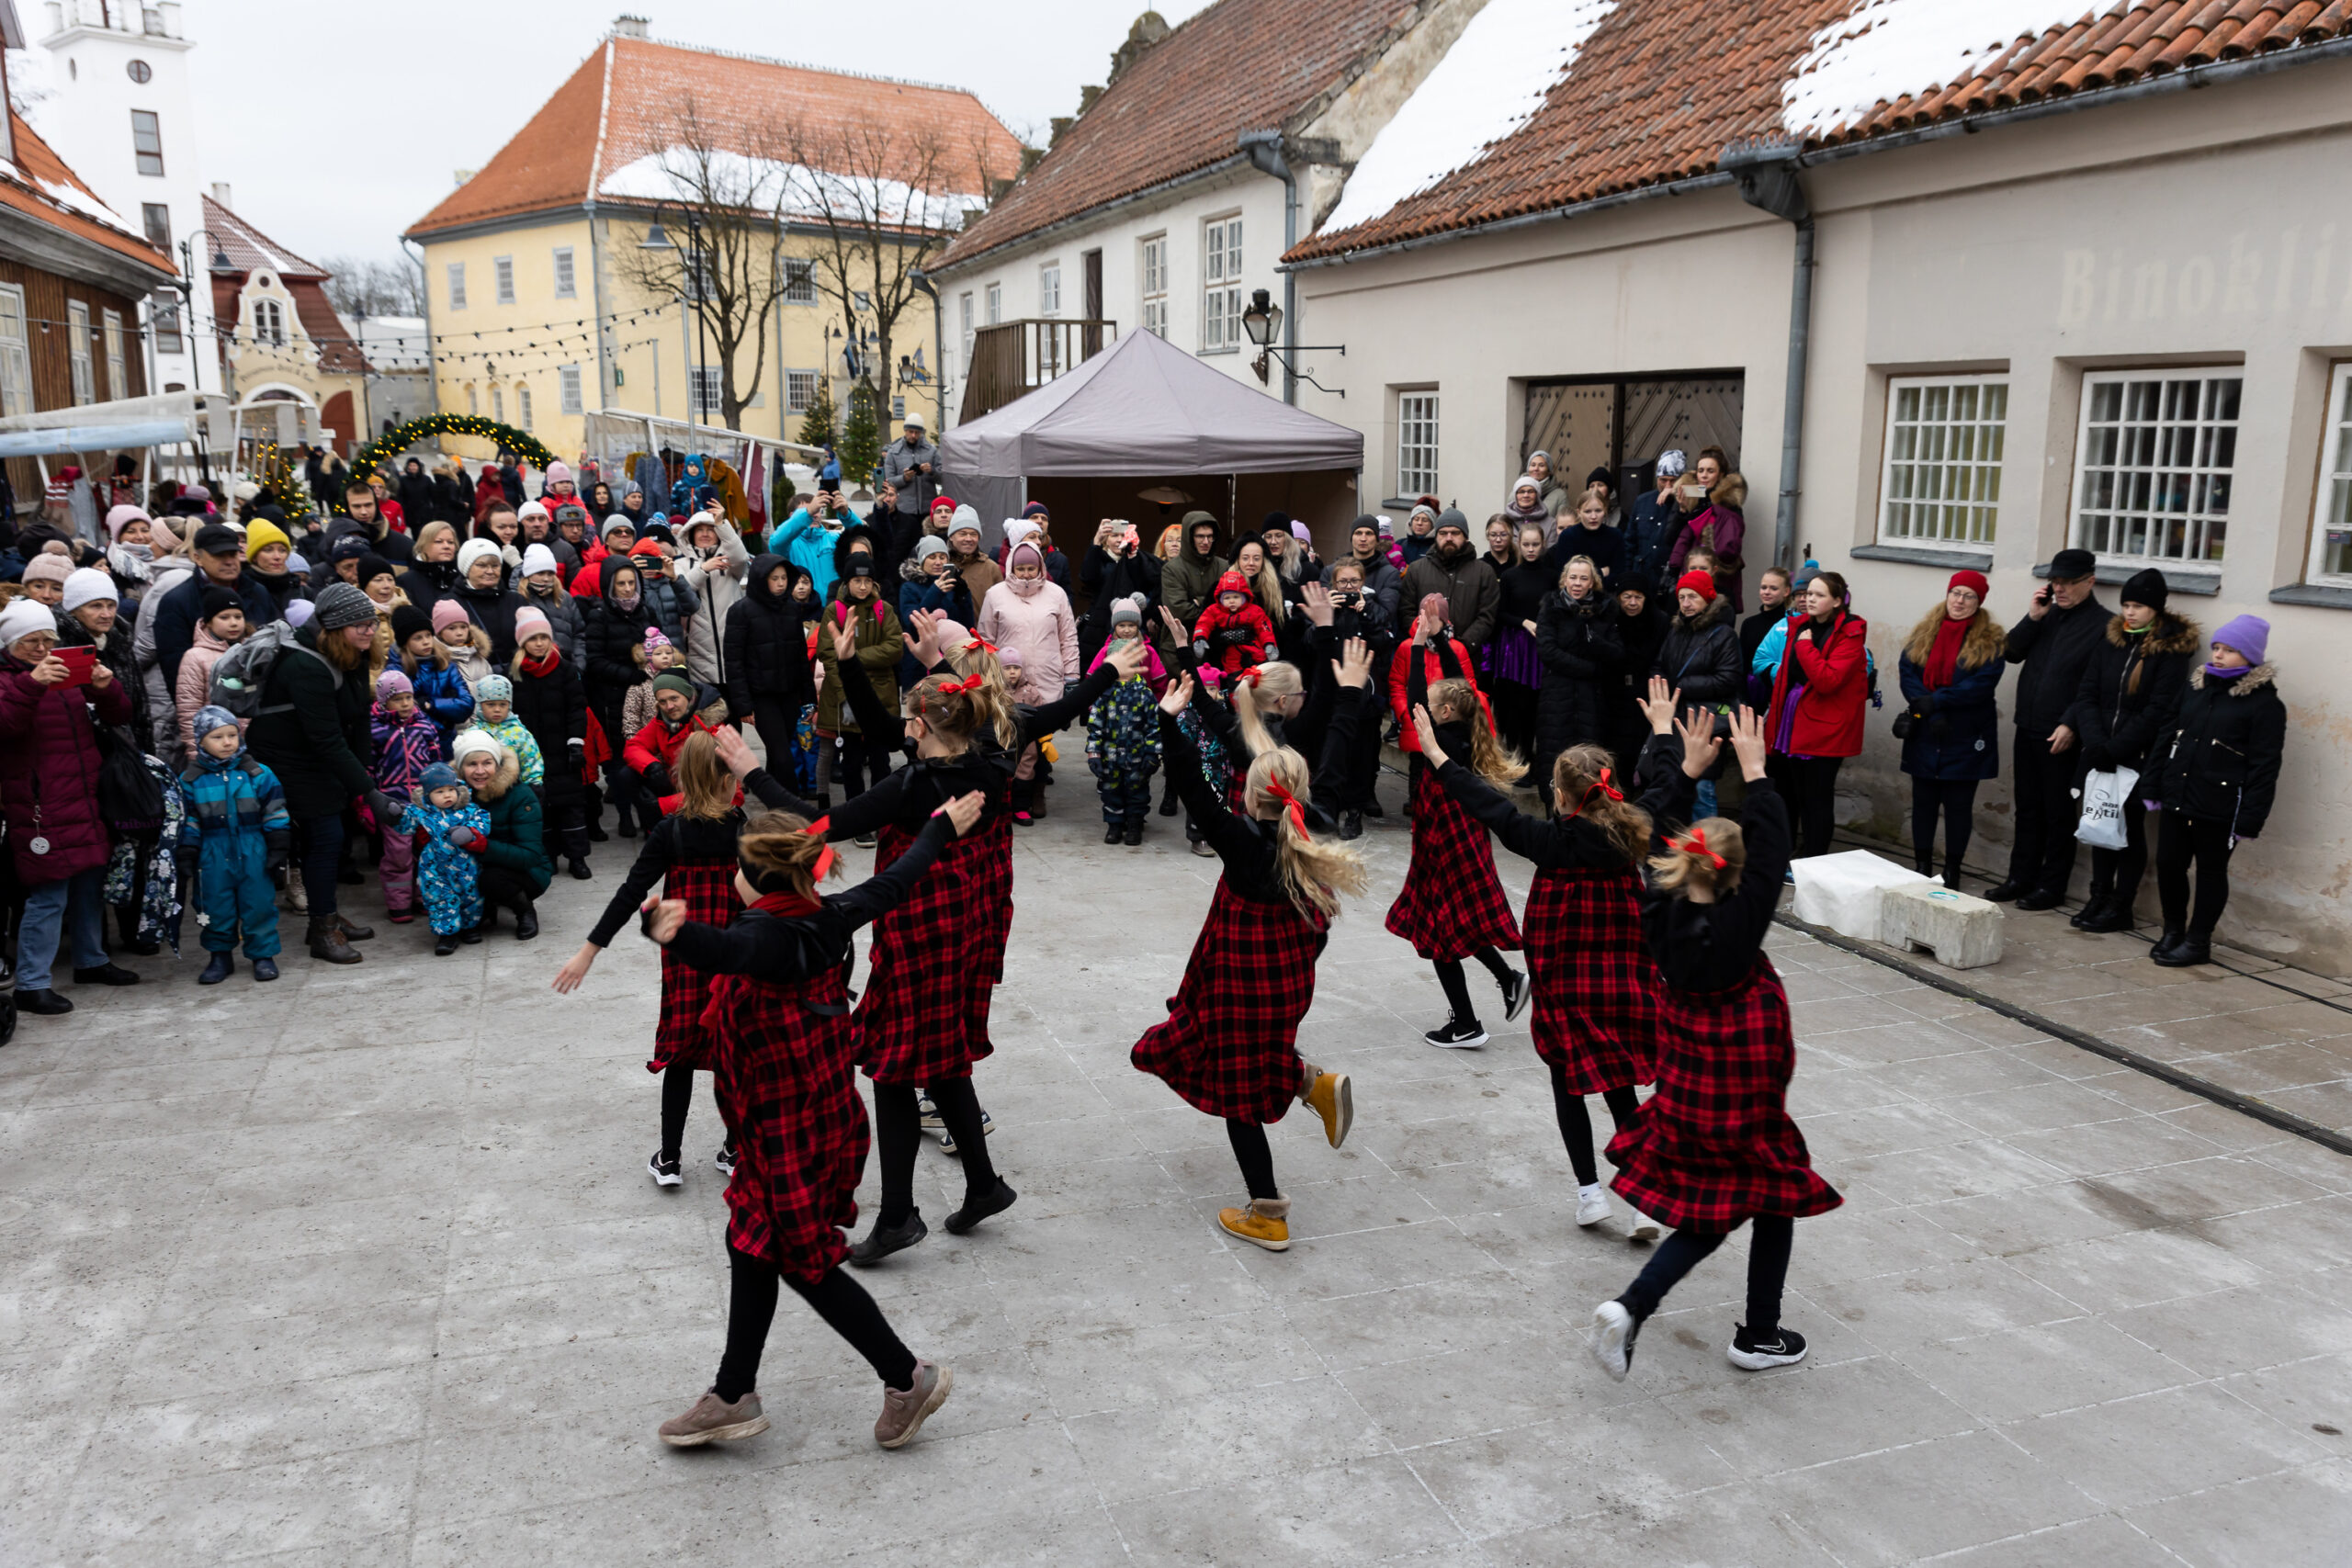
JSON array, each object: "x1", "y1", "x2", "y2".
[{"x1": 0, "y1": 804, "x2": 2352, "y2": 1568}]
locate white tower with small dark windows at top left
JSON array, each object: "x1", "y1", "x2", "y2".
[{"x1": 26, "y1": 0, "x2": 221, "y2": 392}]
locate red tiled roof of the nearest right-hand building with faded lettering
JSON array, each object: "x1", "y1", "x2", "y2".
[{"x1": 1289, "y1": 0, "x2": 2352, "y2": 261}]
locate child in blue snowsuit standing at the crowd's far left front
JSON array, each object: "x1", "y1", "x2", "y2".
[{"x1": 179, "y1": 703, "x2": 294, "y2": 985}]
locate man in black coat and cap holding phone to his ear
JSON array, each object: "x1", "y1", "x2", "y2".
[{"x1": 1985, "y1": 550, "x2": 2112, "y2": 909}]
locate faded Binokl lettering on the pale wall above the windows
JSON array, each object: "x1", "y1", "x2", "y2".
[{"x1": 2058, "y1": 223, "x2": 2352, "y2": 327}]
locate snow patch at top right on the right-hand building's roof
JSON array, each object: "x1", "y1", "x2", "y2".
[{"x1": 1781, "y1": 0, "x2": 2124, "y2": 136}]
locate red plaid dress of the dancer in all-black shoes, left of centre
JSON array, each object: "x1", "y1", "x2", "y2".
[{"x1": 856, "y1": 823, "x2": 1012, "y2": 1084}]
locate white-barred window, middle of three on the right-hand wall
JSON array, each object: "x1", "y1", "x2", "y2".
[{"x1": 2075, "y1": 369, "x2": 2244, "y2": 562}]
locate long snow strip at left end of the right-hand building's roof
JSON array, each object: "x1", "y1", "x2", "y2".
[{"x1": 1322, "y1": 0, "x2": 1616, "y2": 235}]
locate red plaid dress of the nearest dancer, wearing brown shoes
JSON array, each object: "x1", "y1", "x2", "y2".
[{"x1": 703, "y1": 968, "x2": 873, "y2": 1283}]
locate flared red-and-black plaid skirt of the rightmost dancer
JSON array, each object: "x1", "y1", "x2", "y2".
[{"x1": 1609, "y1": 954, "x2": 1844, "y2": 1232}]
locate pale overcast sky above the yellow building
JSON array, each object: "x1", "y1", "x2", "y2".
[{"x1": 153, "y1": 0, "x2": 1206, "y2": 270}]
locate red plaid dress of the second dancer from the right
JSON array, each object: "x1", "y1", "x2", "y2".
[{"x1": 1526, "y1": 865, "x2": 1658, "y2": 1096}]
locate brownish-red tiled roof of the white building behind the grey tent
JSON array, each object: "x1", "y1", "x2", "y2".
[{"x1": 933, "y1": 0, "x2": 1419, "y2": 270}]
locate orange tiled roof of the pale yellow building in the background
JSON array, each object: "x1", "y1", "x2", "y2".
[{"x1": 409, "y1": 35, "x2": 1021, "y2": 237}]
